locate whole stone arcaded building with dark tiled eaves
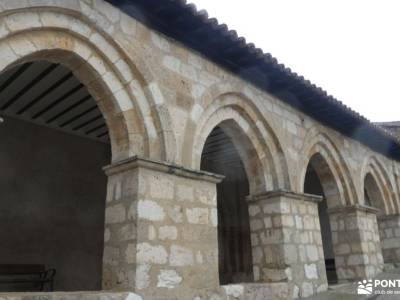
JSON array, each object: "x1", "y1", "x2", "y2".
[{"x1": 0, "y1": 0, "x2": 400, "y2": 300}]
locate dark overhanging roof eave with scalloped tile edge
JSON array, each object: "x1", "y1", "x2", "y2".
[{"x1": 107, "y1": 0, "x2": 400, "y2": 160}]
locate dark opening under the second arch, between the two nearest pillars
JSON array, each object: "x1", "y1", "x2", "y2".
[{"x1": 201, "y1": 126, "x2": 253, "y2": 284}]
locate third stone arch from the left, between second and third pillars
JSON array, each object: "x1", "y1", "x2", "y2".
[{"x1": 298, "y1": 130, "x2": 357, "y2": 205}]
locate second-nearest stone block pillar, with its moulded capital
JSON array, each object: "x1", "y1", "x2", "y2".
[{"x1": 248, "y1": 191, "x2": 328, "y2": 298}]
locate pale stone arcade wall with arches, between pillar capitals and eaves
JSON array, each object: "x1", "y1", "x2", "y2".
[{"x1": 1, "y1": 0, "x2": 400, "y2": 213}]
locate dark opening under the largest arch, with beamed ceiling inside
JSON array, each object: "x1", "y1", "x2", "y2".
[{"x1": 0, "y1": 60, "x2": 111, "y2": 291}]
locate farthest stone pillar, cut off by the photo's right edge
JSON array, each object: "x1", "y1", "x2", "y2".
[{"x1": 378, "y1": 215, "x2": 400, "y2": 265}]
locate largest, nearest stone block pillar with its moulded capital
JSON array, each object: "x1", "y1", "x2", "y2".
[{"x1": 103, "y1": 157, "x2": 222, "y2": 299}]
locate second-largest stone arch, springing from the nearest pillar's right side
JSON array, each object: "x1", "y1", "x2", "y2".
[{"x1": 188, "y1": 93, "x2": 290, "y2": 193}]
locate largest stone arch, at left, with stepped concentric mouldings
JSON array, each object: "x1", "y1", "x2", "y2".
[{"x1": 0, "y1": 7, "x2": 175, "y2": 162}]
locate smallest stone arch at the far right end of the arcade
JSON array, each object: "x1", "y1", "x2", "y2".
[{"x1": 360, "y1": 155, "x2": 399, "y2": 214}]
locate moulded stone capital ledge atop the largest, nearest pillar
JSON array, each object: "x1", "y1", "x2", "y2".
[{"x1": 103, "y1": 155, "x2": 225, "y2": 183}]
